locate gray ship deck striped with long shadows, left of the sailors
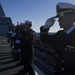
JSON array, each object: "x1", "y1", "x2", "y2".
[{"x1": 0, "y1": 37, "x2": 28, "y2": 75}]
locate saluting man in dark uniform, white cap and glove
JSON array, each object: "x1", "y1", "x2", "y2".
[{"x1": 40, "y1": 2, "x2": 75, "y2": 75}]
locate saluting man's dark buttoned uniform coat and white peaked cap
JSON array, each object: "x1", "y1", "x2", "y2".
[{"x1": 40, "y1": 3, "x2": 75, "y2": 75}]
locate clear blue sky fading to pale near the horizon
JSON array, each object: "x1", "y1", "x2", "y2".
[{"x1": 0, "y1": 0, "x2": 75, "y2": 32}]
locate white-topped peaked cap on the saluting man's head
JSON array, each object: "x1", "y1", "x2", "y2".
[{"x1": 55, "y1": 2, "x2": 75, "y2": 17}]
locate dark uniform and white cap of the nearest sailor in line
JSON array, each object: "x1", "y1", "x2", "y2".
[{"x1": 17, "y1": 21, "x2": 35, "y2": 75}]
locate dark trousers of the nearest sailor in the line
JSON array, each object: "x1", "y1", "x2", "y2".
[{"x1": 21, "y1": 50, "x2": 35, "y2": 75}]
